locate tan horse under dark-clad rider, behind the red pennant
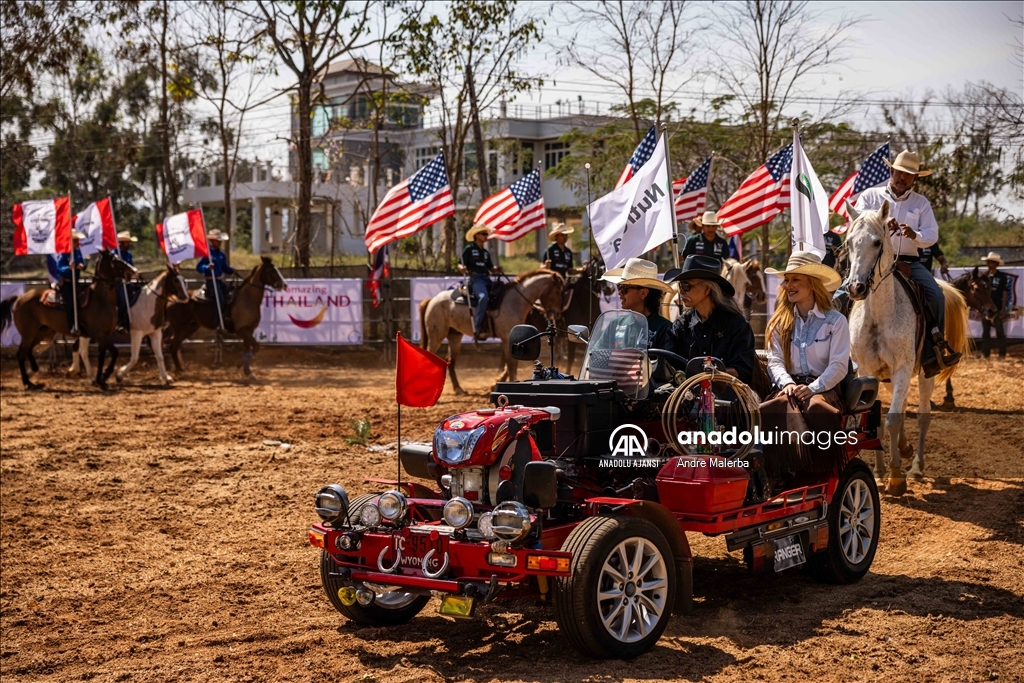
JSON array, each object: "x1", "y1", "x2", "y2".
[{"x1": 420, "y1": 268, "x2": 565, "y2": 395}]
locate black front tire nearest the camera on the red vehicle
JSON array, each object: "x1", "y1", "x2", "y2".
[{"x1": 552, "y1": 515, "x2": 677, "y2": 659}]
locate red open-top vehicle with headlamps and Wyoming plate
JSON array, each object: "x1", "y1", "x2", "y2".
[{"x1": 309, "y1": 311, "x2": 882, "y2": 658}]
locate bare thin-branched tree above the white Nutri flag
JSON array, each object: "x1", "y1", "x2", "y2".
[{"x1": 562, "y1": 0, "x2": 707, "y2": 142}]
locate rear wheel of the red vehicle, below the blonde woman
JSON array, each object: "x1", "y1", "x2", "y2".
[{"x1": 807, "y1": 459, "x2": 882, "y2": 584}]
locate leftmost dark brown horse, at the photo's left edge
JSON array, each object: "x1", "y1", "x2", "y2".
[{"x1": 0, "y1": 251, "x2": 137, "y2": 391}]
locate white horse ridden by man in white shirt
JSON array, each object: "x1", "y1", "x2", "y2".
[{"x1": 846, "y1": 202, "x2": 968, "y2": 496}]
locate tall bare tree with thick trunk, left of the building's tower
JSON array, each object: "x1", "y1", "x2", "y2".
[{"x1": 256, "y1": 0, "x2": 373, "y2": 275}]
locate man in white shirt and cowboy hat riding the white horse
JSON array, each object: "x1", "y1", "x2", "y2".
[{"x1": 856, "y1": 150, "x2": 962, "y2": 377}]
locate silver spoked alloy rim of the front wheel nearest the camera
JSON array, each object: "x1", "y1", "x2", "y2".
[{"x1": 597, "y1": 537, "x2": 669, "y2": 643}]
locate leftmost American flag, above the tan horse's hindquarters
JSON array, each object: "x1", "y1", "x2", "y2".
[{"x1": 366, "y1": 155, "x2": 455, "y2": 252}]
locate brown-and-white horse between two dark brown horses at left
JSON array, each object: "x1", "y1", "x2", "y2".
[{"x1": 68, "y1": 266, "x2": 188, "y2": 384}]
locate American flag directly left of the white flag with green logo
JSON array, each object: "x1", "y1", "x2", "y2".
[{"x1": 718, "y1": 142, "x2": 793, "y2": 236}]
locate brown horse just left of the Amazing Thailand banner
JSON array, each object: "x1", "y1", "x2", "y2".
[{"x1": 167, "y1": 256, "x2": 288, "y2": 379}]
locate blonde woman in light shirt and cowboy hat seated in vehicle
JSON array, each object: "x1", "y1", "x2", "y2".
[{"x1": 761, "y1": 252, "x2": 850, "y2": 469}]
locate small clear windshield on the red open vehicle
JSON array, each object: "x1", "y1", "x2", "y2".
[{"x1": 580, "y1": 310, "x2": 650, "y2": 399}]
